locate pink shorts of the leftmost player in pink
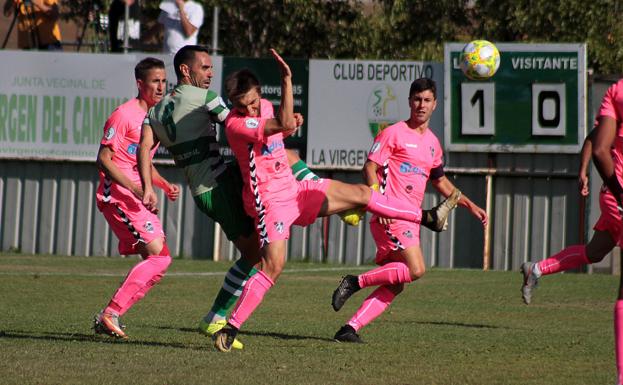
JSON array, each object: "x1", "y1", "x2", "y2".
[{"x1": 97, "y1": 199, "x2": 164, "y2": 255}]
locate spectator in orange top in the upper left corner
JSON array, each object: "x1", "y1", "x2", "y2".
[{"x1": 4, "y1": 0, "x2": 63, "y2": 51}]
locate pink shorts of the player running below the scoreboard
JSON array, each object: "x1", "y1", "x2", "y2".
[{"x1": 370, "y1": 218, "x2": 420, "y2": 265}]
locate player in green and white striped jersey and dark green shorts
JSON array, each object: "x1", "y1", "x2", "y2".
[{"x1": 139, "y1": 46, "x2": 316, "y2": 349}]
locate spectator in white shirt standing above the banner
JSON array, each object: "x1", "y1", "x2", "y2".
[{"x1": 158, "y1": 0, "x2": 203, "y2": 55}]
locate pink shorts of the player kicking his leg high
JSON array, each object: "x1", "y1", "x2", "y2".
[{"x1": 255, "y1": 179, "x2": 330, "y2": 247}]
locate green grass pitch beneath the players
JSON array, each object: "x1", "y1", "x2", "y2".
[{"x1": 0, "y1": 255, "x2": 618, "y2": 385}]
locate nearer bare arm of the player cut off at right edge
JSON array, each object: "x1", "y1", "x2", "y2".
[{"x1": 592, "y1": 116, "x2": 623, "y2": 206}]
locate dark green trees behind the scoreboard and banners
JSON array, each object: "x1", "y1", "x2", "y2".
[{"x1": 59, "y1": 0, "x2": 623, "y2": 73}]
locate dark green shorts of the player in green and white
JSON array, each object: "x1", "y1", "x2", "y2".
[{"x1": 193, "y1": 163, "x2": 254, "y2": 241}]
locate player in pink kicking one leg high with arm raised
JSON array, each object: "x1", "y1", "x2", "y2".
[{"x1": 214, "y1": 50, "x2": 460, "y2": 351}]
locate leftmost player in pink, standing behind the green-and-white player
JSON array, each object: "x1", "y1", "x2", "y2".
[{"x1": 93, "y1": 58, "x2": 179, "y2": 339}]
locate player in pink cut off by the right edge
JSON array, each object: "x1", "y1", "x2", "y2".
[{"x1": 521, "y1": 80, "x2": 623, "y2": 385}]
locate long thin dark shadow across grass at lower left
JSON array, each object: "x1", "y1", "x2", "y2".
[{"x1": 0, "y1": 330, "x2": 216, "y2": 352}]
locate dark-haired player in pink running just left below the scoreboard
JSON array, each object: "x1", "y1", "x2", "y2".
[{"x1": 332, "y1": 78, "x2": 487, "y2": 343}]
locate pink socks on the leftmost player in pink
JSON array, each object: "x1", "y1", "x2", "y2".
[{"x1": 104, "y1": 255, "x2": 171, "y2": 316}]
